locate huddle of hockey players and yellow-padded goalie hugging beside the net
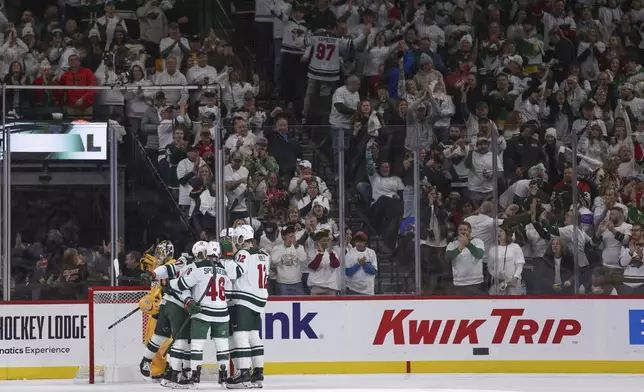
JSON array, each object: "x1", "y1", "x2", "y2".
[{"x1": 133, "y1": 225, "x2": 270, "y2": 389}]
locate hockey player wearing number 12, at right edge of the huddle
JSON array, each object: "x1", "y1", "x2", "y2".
[{"x1": 226, "y1": 225, "x2": 270, "y2": 389}]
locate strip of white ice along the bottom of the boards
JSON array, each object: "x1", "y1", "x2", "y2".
[{"x1": 0, "y1": 374, "x2": 644, "y2": 392}]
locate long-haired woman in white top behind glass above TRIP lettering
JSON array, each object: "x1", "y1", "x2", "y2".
[{"x1": 487, "y1": 227, "x2": 525, "y2": 295}]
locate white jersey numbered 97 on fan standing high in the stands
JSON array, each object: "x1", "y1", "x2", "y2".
[{"x1": 304, "y1": 31, "x2": 365, "y2": 82}]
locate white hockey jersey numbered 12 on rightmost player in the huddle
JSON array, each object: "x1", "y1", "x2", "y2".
[{"x1": 226, "y1": 248, "x2": 271, "y2": 313}]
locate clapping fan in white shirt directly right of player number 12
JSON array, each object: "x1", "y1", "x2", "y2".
[{"x1": 271, "y1": 225, "x2": 307, "y2": 295}]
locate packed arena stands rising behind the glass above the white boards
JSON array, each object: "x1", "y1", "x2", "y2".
[{"x1": 0, "y1": 0, "x2": 644, "y2": 300}]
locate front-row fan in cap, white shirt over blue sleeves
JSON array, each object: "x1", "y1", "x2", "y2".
[{"x1": 344, "y1": 231, "x2": 378, "y2": 295}]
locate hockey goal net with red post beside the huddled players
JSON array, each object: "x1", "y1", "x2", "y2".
[{"x1": 76, "y1": 287, "x2": 226, "y2": 384}]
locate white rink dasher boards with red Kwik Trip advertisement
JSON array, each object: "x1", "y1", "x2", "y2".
[{"x1": 0, "y1": 296, "x2": 644, "y2": 380}]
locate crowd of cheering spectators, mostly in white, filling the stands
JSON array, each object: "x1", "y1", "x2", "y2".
[{"x1": 0, "y1": 0, "x2": 644, "y2": 295}]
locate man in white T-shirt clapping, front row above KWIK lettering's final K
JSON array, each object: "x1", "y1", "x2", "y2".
[{"x1": 445, "y1": 221, "x2": 485, "y2": 295}]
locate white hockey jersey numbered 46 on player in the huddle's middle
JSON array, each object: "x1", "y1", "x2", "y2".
[{"x1": 170, "y1": 260, "x2": 230, "y2": 323}]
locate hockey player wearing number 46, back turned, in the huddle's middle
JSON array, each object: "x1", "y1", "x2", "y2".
[{"x1": 170, "y1": 241, "x2": 230, "y2": 386}]
